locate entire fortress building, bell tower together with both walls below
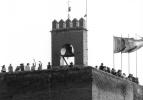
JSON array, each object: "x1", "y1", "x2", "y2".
[{"x1": 0, "y1": 18, "x2": 143, "y2": 100}]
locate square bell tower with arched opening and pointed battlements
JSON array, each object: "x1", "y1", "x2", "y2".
[{"x1": 51, "y1": 18, "x2": 88, "y2": 66}]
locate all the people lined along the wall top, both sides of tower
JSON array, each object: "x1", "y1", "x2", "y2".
[{"x1": 1, "y1": 61, "x2": 139, "y2": 84}]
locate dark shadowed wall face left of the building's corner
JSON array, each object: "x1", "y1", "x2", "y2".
[{"x1": 0, "y1": 67, "x2": 92, "y2": 100}]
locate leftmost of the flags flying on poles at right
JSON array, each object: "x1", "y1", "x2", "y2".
[{"x1": 113, "y1": 37, "x2": 125, "y2": 53}]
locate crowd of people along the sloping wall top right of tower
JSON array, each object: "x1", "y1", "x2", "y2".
[{"x1": 95, "y1": 63, "x2": 139, "y2": 84}]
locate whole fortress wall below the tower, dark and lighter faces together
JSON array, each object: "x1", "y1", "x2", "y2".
[{"x1": 0, "y1": 66, "x2": 143, "y2": 100}]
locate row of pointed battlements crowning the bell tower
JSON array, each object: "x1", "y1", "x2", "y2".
[{"x1": 52, "y1": 18, "x2": 86, "y2": 31}]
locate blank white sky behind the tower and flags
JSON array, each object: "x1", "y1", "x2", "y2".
[{"x1": 0, "y1": 0, "x2": 143, "y2": 85}]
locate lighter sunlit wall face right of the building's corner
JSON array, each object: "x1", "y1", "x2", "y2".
[{"x1": 92, "y1": 69, "x2": 143, "y2": 100}]
